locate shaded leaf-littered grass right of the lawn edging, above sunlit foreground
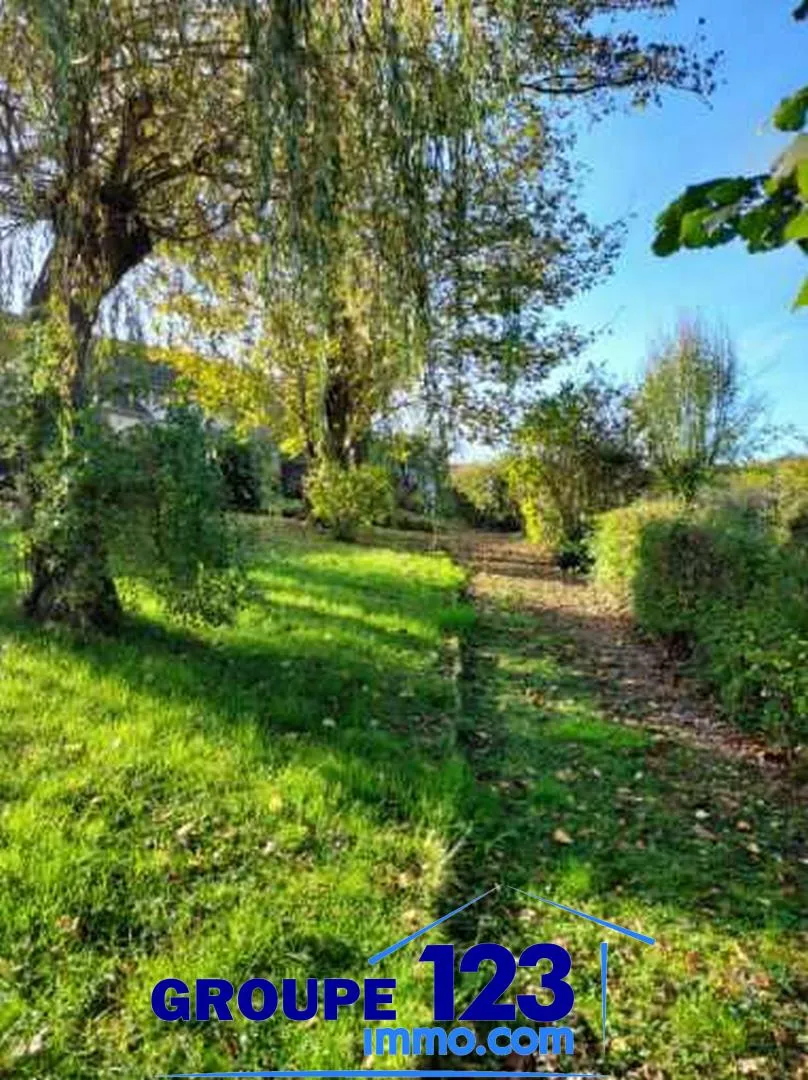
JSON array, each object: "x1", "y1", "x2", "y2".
[{"x1": 445, "y1": 591, "x2": 808, "y2": 946}]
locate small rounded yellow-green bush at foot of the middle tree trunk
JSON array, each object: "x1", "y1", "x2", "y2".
[{"x1": 306, "y1": 461, "x2": 394, "y2": 540}]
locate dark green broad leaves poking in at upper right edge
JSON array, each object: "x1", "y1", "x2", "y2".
[{"x1": 654, "y1": 4, "x2": 808, "y2": 309}]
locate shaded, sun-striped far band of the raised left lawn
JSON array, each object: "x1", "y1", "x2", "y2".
[{"x1": 0, "y1": 540, "x2": 470, "y2": 842}]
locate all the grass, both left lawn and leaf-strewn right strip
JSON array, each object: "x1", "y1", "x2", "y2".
[{"x1": 0, "y1": 526, "x2": 808, "y2": 1080}]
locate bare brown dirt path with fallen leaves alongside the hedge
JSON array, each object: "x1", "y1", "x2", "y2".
[{"x1": 450, "y1": 534, "x2": 784, "y2": 774}]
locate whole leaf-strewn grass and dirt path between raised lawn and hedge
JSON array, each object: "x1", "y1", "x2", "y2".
[{"x1": 356, "y1": 531, "x2": 808, "y2": 1080}]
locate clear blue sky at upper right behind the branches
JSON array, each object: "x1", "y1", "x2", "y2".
[{"x1": 567, "y1": 0, "x2": 808, "y2": 447}]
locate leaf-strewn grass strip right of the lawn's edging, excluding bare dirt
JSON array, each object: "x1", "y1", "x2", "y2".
[{"x1": 455, "y1": 579, "x2": 808, "y2": 1080}]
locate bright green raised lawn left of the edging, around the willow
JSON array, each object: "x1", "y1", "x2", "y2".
[{"x1": 0, "y1": 518, "x2": 470, "y2": 1078}]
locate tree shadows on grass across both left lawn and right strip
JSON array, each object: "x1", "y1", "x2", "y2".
[{"x1": 4, "y1": 531, "x2": 806, "y2": 934}]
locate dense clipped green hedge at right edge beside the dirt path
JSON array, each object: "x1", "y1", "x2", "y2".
[{"x1": 596, "y1": 503, "x2": 808, "y2": 743}]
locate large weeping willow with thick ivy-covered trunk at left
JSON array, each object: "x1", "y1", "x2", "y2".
[{"x1": 0, "y1": 0, "x2": 710, "y2": 624}]
